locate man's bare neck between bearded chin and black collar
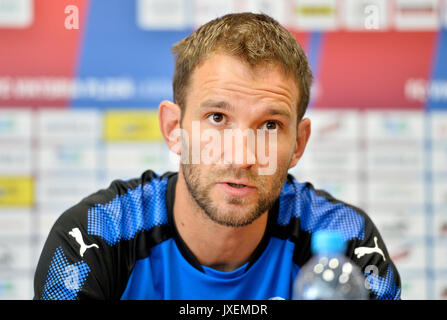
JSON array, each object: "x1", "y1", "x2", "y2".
[{"x1": 173, "y1": 170, "x2": 268, "y2": 272}]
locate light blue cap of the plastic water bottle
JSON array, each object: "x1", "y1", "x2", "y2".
[{"x1": 311, "y1": 230, "x2": 346, "y2": 254}]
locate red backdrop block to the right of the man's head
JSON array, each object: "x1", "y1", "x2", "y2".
[{"x1": 314, "y1": 31, "x2": 437, "y2": 109}]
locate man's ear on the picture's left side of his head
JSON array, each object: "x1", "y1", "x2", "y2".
[{"x1": 158, "y1": 100, "x2": 181, "y2": 155}]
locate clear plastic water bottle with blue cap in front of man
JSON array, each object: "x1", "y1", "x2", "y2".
[{"x1": 292, "y1": 231, "x2": 369, "y2": 300}]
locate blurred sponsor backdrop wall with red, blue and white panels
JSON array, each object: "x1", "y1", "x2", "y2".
[{"x1": 0, "y1": 0, "x2": 447, "y2": 299}]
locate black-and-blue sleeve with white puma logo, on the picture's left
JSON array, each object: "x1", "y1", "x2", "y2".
[{"x1": 34, "y1": 202, "x2": 117, "y2": 300}]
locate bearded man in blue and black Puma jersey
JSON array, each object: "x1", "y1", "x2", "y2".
[{"x1": 34, "y1": 13, "x2": 400, "y2": 299}]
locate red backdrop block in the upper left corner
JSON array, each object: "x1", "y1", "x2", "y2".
[{"x1": 0, "y1": 0, "x2": 88, "y2": 107}]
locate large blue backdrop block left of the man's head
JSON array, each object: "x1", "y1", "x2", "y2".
[{"x1": 71, "y1": 0, "x2": 191, "y2": 108}]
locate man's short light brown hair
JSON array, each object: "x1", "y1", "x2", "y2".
[{"x1": 172, "y1": 13, "x2": 313, "y2": 121}]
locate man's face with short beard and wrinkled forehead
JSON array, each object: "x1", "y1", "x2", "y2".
[{"x1": 181, "y1": 54, "x2": 299, "y2": 227}]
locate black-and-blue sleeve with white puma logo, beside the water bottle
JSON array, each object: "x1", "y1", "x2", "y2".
[{"x1": 347, "y1": 214, "x2": 401, "y2": 300}]
